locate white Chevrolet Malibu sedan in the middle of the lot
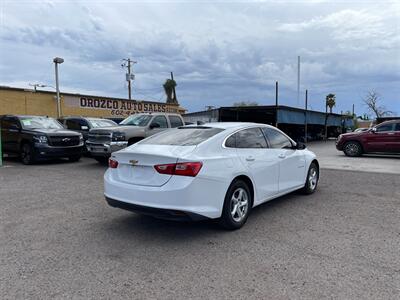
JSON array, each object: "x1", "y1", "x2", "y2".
[{"x1": 104, "y1": 123, "x2": 319, "y2": 229}]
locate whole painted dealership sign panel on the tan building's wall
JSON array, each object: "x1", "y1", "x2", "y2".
[{"x1": 64, "y1": 95, "x2": 180, "y2": 116}]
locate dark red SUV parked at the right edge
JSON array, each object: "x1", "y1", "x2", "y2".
[{"x1": 336, "y1": 120, "x2": 400, "y2": 156}]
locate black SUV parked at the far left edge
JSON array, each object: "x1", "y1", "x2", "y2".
[{"x1": 0, "y1": 115, "x2": 84, "y2": 165}]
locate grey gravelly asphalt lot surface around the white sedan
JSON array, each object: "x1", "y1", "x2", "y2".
[{"x1": 0, "y1": 158, "x2": 400, "y2": 299}]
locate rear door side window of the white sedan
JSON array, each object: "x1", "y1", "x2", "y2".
[{"x1": 225, "y1": 128, "x2": 268, "y2": 148}]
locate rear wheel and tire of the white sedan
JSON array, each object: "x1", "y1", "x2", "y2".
[{"x1": 219, "y1": 180, "x2": 253, "y2": 230}]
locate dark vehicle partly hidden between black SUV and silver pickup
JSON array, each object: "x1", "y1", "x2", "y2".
[{"x1": 58, "y1": 117, "x2": 118, "y2": 141}]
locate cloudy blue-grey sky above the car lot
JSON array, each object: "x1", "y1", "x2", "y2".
[{"x1": 0, "y1": 0, "x2": 400, "y2": 115}]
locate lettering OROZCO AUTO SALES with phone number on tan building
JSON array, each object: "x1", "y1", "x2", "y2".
[{"x1": 79, "y1": 97, "x2": 177, "y2": 116}]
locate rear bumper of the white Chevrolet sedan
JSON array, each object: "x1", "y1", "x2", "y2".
[{"x1": 104, "y1": 169, "x2": 229, "y2": 219}]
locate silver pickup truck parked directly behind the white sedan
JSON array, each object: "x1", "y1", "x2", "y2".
[{"x1": 86, "y1": 113, "x2": 185, "y2": 162}]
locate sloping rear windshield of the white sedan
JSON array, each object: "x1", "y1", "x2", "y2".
[{"x1": 141, "y1": 127, "x2": 223, "y2": 146}]
